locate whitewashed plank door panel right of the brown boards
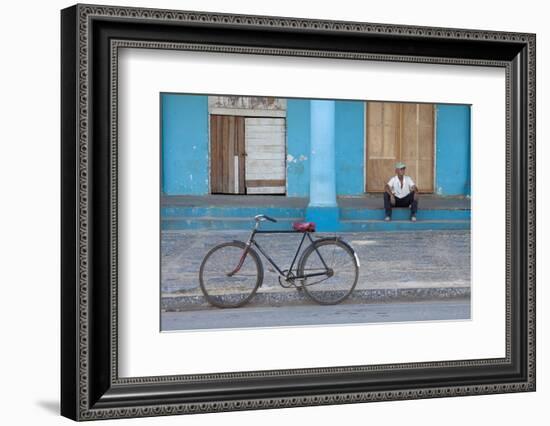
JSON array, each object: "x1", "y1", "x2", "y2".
[{"x1": 245, "y1": 117, "x2": 286, "y2": 194}]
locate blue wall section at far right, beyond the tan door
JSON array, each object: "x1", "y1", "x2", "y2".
[{"x1": 435, "y1": 105, "x2": 471, "y2": 195}]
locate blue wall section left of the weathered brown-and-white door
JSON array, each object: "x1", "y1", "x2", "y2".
[{"x1": 161, "y1": 94, "x2": 209, "y2": 195}]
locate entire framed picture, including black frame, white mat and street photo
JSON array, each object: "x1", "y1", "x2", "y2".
[{"x1": 61, "y1": 5, "x2": 536, "y2": 420}]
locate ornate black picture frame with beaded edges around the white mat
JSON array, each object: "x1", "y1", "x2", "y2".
[{"x1": 61, "y1": 5, "x2": 535, "y2": 420}]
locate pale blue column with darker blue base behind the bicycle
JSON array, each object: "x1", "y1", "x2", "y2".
[{"x1": 306, "y1": 101, "x2": 339, "y2": 231}]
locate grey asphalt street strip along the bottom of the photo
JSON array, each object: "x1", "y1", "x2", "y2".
[{"x1": 161, "y1": 300, "x2": 470, "y2": 331}]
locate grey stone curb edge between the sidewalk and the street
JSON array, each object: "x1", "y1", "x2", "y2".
[{"x1": 161, "y1": 287, "x2": 471, "y2": 312}]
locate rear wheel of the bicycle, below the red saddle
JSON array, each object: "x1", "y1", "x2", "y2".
[{"x1": 298, "y1": 238, "x2": 359, "y2": 305}]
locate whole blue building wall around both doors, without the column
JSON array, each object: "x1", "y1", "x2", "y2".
[{"x1": 161, "y1": 94, "x2": 470, "y2": 197}]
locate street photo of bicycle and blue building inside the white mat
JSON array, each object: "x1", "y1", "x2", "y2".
[{"x1": 160, "y1": 93, "x2": 471, "y2": 331}]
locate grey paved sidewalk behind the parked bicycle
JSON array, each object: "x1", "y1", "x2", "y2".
[{"x1": 161, "y1": 231, "x2": 470, "y2": 311}]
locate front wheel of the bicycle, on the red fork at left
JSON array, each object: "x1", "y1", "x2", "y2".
[{"x1": 199, "y1": 241, "x2": 263, "y2": 308}]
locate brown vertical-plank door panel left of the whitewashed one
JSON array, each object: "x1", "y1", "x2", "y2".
[{"x1": 210, "y1": 115, "x2": 245, "y2": 194}]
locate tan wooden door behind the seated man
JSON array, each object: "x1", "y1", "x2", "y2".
[{"x1": 365, "y1": 102, "x2": 434, "y2": 192}]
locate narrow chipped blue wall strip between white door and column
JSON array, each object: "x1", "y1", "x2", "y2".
[{"x1": 286, "y1": 99, "x2": 311, "y2": 197}]
